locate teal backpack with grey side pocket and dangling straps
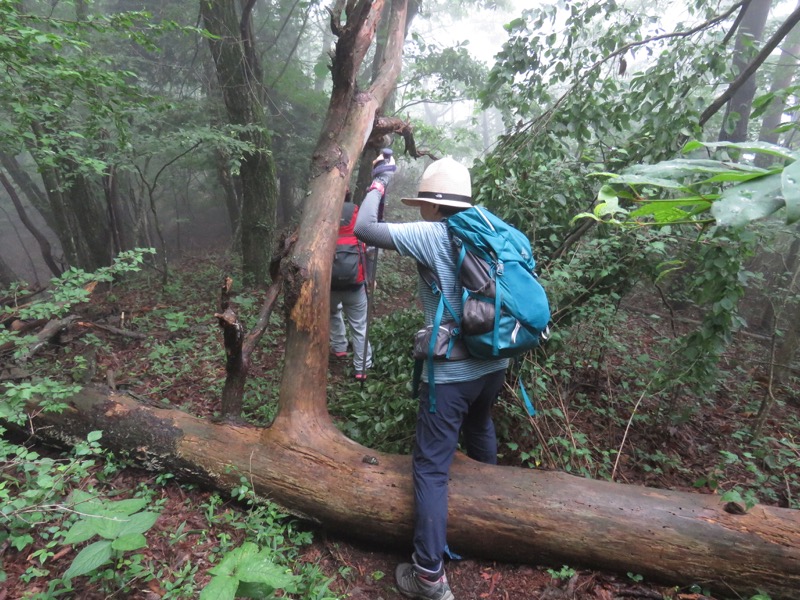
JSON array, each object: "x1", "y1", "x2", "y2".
[{"x1": 415, "y1": 206, "x2": 550, "y2": 416}]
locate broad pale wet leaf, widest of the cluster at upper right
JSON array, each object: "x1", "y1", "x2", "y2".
[{"x1": 711, "y1": 175, "x2": 784, "y2": 227}]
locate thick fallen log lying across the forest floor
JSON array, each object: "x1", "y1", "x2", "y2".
[{"x1": 18, "y1": 388, "x2": 800, "y2": 600}]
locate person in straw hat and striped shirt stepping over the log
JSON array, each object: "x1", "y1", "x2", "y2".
[{"x1": 355, "y1": 155, "x2": 550, "y2": 600}]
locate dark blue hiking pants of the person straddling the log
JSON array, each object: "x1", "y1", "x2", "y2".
[{"x1": 412, "y1": 369, "x2": 505, "y2": 571}]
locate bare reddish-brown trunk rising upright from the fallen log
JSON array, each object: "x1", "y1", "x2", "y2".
[{"x1": 278, "y1": 0, "x2": 406, "y2": 427}]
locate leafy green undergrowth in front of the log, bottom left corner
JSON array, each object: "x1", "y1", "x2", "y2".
[{"x1": 0, "y1": 424, "x2": 339, "y2": 600}]
